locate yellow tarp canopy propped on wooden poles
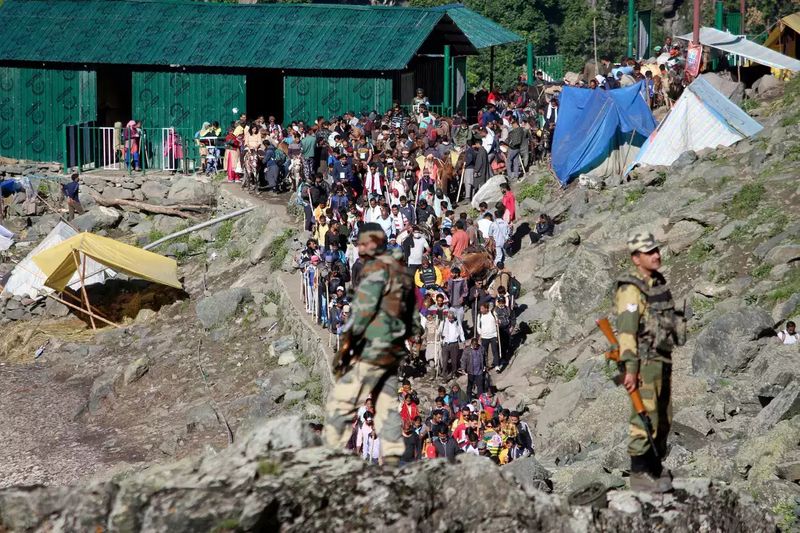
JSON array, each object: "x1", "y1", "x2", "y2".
[{"x1": 33, "y1": 232, "x2": 183, "y2": 291}]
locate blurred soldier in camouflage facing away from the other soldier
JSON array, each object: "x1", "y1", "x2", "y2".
[{"x1": 325, "y1": 223, "x2": 421, "y2": 464}]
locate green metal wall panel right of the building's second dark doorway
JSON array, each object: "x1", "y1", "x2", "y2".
[{"x1": 283, "y1": 76, "x2": 392, "y2": 123}]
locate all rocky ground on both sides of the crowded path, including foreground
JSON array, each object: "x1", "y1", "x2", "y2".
[{"x1": 0, "y1": 77, "x2": 800, "y2": 532}]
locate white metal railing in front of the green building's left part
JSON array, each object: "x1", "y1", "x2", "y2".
[{"x1": 63, "y1": 122, "x2": 208, "y2": 174}]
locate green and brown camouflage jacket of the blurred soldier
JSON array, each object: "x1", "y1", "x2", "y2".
[{"x1": 349, "y1": 249, "x2": 422, "y2": 364}]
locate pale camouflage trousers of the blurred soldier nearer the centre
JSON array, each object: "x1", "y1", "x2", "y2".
[{"x1": 325, "y1": 360, "x2": 405, "y2": 457}]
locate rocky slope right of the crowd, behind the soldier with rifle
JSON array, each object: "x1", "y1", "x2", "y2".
[{"x1": 505, "y1": 76, "x2": 800, "y2": 527}]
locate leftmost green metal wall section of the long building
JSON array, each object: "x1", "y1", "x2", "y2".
[{"x1": 0, "y1": 67, "x2": 97, "y2": 162}]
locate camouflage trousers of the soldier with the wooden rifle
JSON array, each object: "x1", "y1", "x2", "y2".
[{"x1": 628, "y1": 361, "x2": 672, "y2": 458}]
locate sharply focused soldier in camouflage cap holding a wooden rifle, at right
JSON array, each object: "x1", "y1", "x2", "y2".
[{"x1": 614, "y1": 231, "x2": 679, "y2": 492}]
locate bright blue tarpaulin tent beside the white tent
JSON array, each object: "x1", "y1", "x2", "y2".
[{"x1": 553, "y1": 82, "x2": 656, "y2": 185}]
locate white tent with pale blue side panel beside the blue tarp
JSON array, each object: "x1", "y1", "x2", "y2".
[{"x1": 634, "y1": 77, "x2": 763, "y2": 171}]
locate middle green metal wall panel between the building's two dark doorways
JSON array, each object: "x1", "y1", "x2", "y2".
[{"x1": 133, "y1": 72, "x2": 246, "y2": 130}]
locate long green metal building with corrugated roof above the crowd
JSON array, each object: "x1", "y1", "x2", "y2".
[{"x1": 0, "y1": 0, "x2": 521, "y2": 162}]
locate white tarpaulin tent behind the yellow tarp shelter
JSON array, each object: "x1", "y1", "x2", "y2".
[{"x1": 3, "y1": 222, "x2": 116, "y2": 298}]
